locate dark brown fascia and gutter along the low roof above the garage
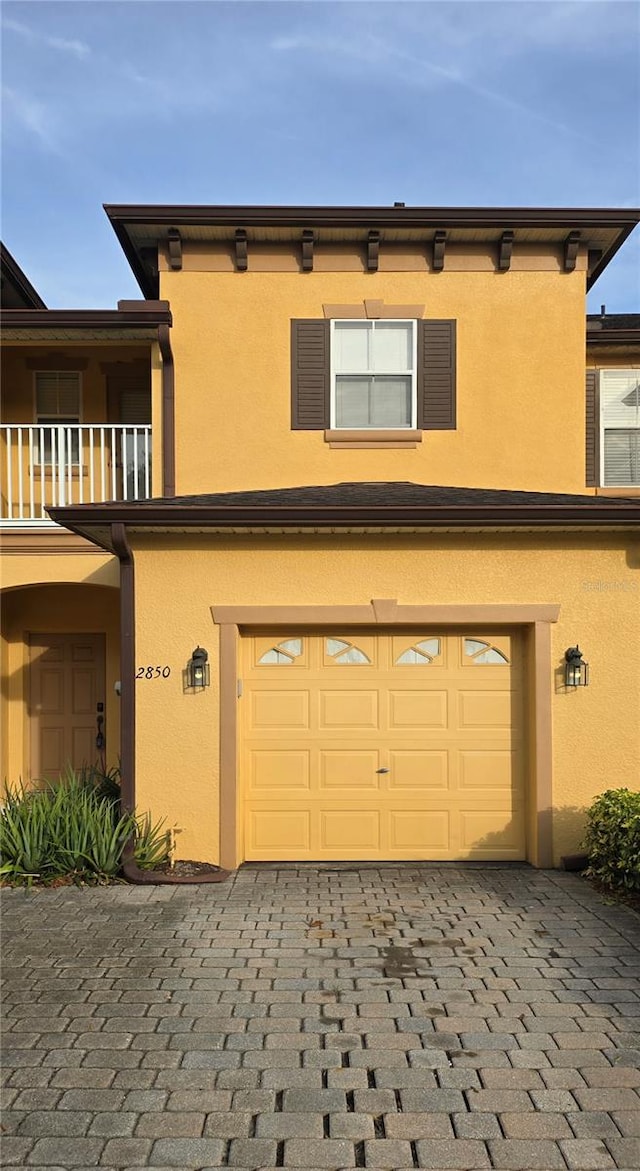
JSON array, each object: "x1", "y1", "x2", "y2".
[{"x1": 48, "y1": 497, "x2": 640, "y2": 540}]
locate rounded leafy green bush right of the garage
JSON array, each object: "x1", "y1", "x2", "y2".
[{"x1": 584, "y1": 789, "x2": 640, "y2": 891}]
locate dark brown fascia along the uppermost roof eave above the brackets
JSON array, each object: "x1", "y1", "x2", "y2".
[{"x1": 104, "y1": 204, "x2": 640, "y2": 296}]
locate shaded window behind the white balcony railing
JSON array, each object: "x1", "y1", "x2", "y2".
[{"x1": 35, "y1": 370, "x2": 80, "y2": 464}]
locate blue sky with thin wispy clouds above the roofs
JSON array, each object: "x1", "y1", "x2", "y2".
[{"x1": 1, "y1": 0, "x2": 640, "y2": 313}]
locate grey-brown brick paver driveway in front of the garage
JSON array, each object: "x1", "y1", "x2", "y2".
[{"x1": 2, "y1": 865, "x2": 640, "y2": 1171}]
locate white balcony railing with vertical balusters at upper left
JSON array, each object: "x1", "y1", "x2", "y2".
[{"x1": 0, "y1": 423, "x2": 151, "y2": 527}]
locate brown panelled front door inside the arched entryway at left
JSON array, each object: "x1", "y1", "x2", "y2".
[{"x1": 29, "y1": 635, "x2": 105, "y2": 781}]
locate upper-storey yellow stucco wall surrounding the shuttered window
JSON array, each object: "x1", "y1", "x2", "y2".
[{"x1": 160, "y1": 269, "x2": 592, "y2": 494}]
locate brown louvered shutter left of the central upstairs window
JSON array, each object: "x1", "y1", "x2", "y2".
[{"x1": 291, "y1": 320, "x2": 330, "y2": 431}]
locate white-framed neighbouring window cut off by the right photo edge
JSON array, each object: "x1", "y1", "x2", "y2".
[{"x1": 600, "y1": 370, "x2": 640, "y2": 487}]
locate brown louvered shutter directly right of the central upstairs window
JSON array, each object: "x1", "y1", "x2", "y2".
[{"x1": 418, "y1": 321, "x2": 456, "y2": 431}]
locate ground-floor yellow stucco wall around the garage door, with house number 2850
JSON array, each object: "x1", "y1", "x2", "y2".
[{"x1": 133, "y1": 534, "x2": 640, "y2": 861}]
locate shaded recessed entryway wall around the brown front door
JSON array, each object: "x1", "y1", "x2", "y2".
[{"x1": 0, "y1": 580, "x2": 121, "y2": 783}]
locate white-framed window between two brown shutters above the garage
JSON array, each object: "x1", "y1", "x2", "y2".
[{"x1": 331, "y1": 320, "x2": 417, "y2": 431}]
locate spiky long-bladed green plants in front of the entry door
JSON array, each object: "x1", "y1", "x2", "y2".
[{"x1": 0, "y1": 769, "x2": 168, "y2": 884}]
